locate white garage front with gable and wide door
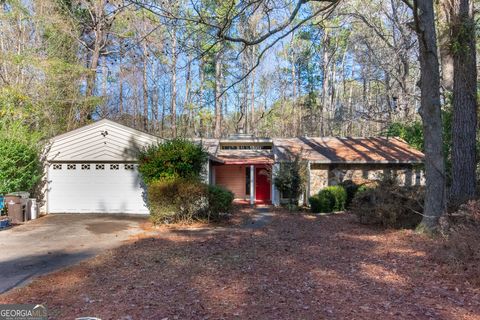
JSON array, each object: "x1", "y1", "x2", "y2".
[{"x1": 45, "y1": 120, "x2": 160, "y2": 214}]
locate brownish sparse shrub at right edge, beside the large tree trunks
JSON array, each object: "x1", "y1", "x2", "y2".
[{"x1": 435, "y1": 200, "x2": 480, "y2": 284}]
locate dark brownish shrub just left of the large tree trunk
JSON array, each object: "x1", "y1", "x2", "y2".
[{"x1": 350, "y1": 180, "x2": 424, "y2": 228}]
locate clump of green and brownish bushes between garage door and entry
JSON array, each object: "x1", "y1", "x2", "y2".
[{"x1": 139, "y1": 139, "x2": 234, "y2": 224}]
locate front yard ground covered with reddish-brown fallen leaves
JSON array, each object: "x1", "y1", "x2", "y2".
[{"x1": 0, "y1": 212, "x2": 480, "y2": 319}]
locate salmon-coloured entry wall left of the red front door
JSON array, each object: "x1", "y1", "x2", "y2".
[{"x1": 214, "y1": 165, "x2": 247, "y2": 199}]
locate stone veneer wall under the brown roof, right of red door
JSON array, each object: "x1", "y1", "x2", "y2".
[{"x1": 310, "y1": 163, "x2": 425, "y2": 196}]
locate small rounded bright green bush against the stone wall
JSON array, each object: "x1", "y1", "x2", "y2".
[{"x1": 308, "y1": 186, "x2": 347, "y2": 213}]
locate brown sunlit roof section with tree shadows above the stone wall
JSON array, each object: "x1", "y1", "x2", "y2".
[{"x1": 274, "y1": 137, "x2": 424, "y2": 163}]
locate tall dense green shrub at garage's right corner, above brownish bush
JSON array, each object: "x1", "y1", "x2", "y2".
[{"x1": 138, "y1": 139, "x2": 208, "y2": 184}]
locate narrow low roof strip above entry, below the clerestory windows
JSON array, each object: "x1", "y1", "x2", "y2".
[{"x1": 215, "y1": 150, "x2": 274, "y2": 164}]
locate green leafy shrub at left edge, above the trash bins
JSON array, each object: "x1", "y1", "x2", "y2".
[{"x1": 0, "y1": 136, "x2": 42, "y2": 194}]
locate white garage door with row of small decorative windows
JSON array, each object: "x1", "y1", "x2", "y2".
[{"x1": 48, "y1": 163, "x2": 148, "y2": 214}]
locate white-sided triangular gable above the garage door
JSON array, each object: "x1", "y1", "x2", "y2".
[{"x1": 47, "y1": 119, "x2": 161, "y2": 161}]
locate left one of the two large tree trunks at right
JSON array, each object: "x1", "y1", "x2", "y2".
[{"x1": 414, "y1": 0, "x2": 445, "y2": 232}]
